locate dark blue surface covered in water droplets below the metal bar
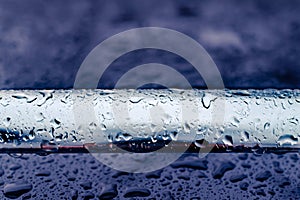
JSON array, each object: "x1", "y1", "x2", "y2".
[{"x1": 0, "y1": 153, "x2": 300, "y2": 199}]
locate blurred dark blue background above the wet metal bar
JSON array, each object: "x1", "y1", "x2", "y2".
[{"x1": 0, "y1": 0, "x2": 300, "y2": 89}]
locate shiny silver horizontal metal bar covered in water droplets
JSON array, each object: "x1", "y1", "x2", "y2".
[{"x1": 0, "y1": 89, "x2": 300, "y2": 153}]
